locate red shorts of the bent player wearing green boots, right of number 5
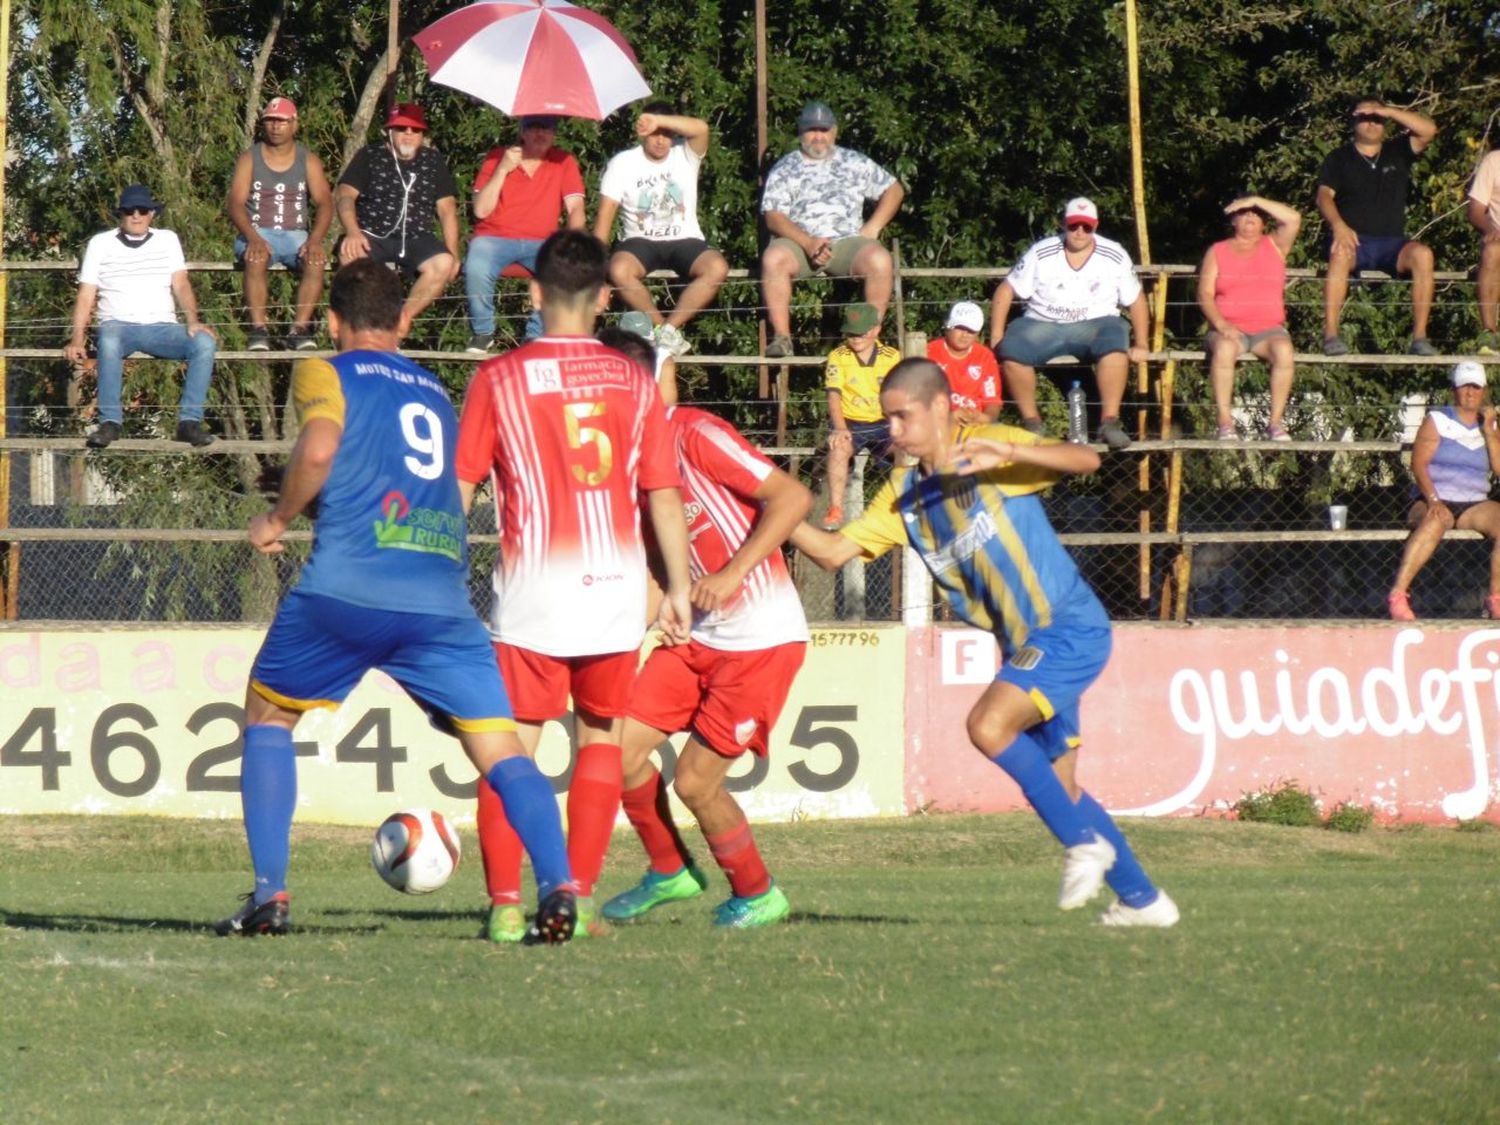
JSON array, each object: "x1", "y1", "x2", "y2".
[{"x1": 626, "y1": 641, "x2": 807, "y2": 758}]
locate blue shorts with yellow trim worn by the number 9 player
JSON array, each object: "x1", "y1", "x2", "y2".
[{"x1": 251, "y1": 590, "x2": 516, "y2": 734}]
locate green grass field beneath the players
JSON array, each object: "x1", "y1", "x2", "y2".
[{"x1": 0, "y1": 815, "x2": 1500, "y2": 1122}]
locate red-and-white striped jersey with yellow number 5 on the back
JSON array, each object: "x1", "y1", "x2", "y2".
[{"x1": 458, "y1": 336, "x2": 681, "y2": 657}]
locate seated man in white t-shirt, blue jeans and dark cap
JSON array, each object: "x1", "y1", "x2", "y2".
[{"x1": 63, "y1": 183, "x2": 218, "y2": 449}]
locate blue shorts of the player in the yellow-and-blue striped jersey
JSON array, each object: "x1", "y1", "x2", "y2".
[{"x1": 995, "y1": 626, "x2": 1110, "y2": 762}]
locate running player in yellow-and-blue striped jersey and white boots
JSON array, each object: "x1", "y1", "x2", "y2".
[{"x1": 791, "y1": 359, "x2": 1178, "y2": 927}]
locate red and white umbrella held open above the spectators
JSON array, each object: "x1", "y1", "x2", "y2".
[{"x1": 413, "y1": 0, "x2": 651, "y2": 122}]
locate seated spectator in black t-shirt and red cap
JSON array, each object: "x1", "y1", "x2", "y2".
[{"x1": 335, "y1": 102, "x2": 459, "y2": 338}]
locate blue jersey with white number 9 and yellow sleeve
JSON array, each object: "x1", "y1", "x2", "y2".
[{"x1": 293, "y1": 351, "x2": 474, "y2": 617}]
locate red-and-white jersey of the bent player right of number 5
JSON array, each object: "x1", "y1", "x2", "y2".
[{"x1": 668, "y1": 407, "x2": 809, "y2": 653}]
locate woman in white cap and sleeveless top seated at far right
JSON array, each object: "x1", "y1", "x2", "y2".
[{"x1": 1386, "y1": 360, "x2": 1500, "y2": 621}]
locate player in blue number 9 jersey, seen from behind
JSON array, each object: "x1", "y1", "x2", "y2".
[{"x1": 215, "y1": 261, "x2": 578, "y2": 944}]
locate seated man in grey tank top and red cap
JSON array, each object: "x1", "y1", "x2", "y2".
[{"x1": 225, "y1": 98, "x2": 333, "y2": 351}]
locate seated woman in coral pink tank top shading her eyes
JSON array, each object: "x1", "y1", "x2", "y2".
[{"x1": 1199, "y1": 195, "x2": 1302, "y2": 441}]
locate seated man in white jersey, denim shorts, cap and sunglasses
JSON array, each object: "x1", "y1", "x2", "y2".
[{"x1": 990, "y1": 197, "x2": 1148, "y2": 450}]
